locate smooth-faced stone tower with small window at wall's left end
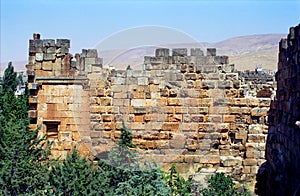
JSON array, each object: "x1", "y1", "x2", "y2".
[{"x1": 26, "y1": 34, "x2": 95, "y2": 157}]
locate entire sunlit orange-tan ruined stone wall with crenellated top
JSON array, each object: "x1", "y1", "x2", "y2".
[{"x1": 27, "y1": 34, "x2": 276, "y2": 189}]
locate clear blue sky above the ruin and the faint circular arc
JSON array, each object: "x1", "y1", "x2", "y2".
[{"x1": 0, "y1": 0, "x2": 300, "y2": 62}]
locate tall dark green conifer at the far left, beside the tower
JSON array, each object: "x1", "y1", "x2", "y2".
[{"x1": 0, "y1": 63, "x2": 50, "y2": 195}]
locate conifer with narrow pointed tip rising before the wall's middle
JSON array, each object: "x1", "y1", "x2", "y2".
[{"x1": 98, "y1": 122, "x2": 171, "y2": 195}]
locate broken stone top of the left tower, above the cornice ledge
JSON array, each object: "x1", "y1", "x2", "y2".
[{"x1": 26, "y1": 33, "x2": 103, "y2": 77}]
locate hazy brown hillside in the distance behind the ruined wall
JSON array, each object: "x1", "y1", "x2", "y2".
[{"x1": 0, "y1": 34, "x2": 286, "y2": 74}]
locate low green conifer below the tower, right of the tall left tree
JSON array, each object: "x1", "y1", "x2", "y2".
[{"x1": 48, "y1": 148, "x2": 99, "y2": 196}]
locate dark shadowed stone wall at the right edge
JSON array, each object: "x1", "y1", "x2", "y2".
[{"x1": 265, "y1": 25, "x2": 300, "y2": 195}]
